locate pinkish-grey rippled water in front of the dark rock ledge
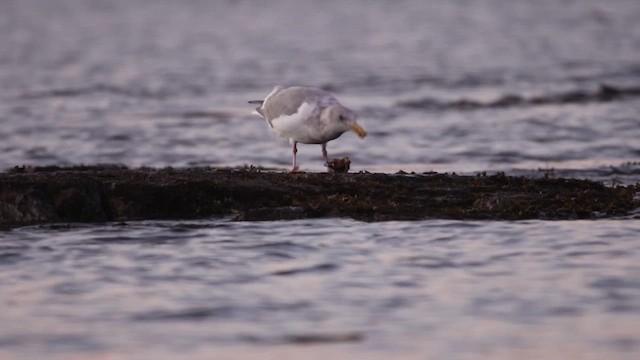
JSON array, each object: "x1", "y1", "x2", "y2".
[{"x1": 0, "y1": 219, "x2": 640, "y2": 359}]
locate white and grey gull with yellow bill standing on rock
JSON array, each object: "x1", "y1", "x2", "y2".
[{"x1": 249, "y1": 86, "x2": 367, "y2": 172}]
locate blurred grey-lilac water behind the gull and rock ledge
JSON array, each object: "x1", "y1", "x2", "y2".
[{"x1": 0, "y1": 0, "x2": 640, "y2": 176}]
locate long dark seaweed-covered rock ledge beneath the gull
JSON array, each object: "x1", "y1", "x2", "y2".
[{"x1": 0, "y1": 166, "x2": 640, "y2": 228}]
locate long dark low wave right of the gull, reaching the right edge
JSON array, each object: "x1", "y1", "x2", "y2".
[{"x1": 396, "y1": 84, "x2": 640, "y2": 110}]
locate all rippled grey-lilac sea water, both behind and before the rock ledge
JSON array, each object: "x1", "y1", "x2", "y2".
[{"x1": 0, "y1": 0, "x2": 640, "y2": 359}]
